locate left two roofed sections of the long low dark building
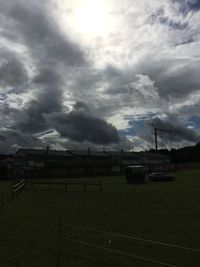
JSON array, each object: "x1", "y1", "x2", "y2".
[{"x1": 15, "y1": 149, "x2": 111, "y2": 178}]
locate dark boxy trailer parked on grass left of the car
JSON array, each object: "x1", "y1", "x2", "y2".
[{"x1": 125, "y1": 165, "x2": 145, "y2": 184}]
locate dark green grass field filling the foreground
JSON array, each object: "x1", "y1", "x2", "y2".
[{"x1": 0, "y1": 170, "x2": 200, "y2": 267}]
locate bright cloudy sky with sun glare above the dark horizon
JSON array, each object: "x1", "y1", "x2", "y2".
[{"x1": 0, "y1": 0, "x2": 200, "y2": 153}]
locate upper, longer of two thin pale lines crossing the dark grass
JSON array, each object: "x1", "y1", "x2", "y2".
[{"x1": 13, "y1": 205, "x2": 200, "y2": 253}]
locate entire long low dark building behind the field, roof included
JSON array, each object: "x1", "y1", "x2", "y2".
[{"x1": 14, "y1": 149, "x2": 170, "y2": 178}]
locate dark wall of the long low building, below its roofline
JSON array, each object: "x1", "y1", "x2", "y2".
[{"x1": 15, "y1": 150, "x2": 168, "y2": 178}]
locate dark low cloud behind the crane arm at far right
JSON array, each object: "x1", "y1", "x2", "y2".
[{"x1": 150, "y1": 115, "x2": 200, "y2": 142}]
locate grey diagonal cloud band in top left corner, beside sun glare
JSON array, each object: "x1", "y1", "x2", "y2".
[{"x1": 0, "y1": 0, "x2": 87, "y2": 102}]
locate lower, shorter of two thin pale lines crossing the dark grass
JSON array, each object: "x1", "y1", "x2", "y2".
[{"x1": 63, "y1": 236, "x2": 177, "y2": 267}]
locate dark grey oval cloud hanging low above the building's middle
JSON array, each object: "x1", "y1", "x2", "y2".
[{"x1": 49, "y1": 102, "x2": 119, "y2": 144}]
